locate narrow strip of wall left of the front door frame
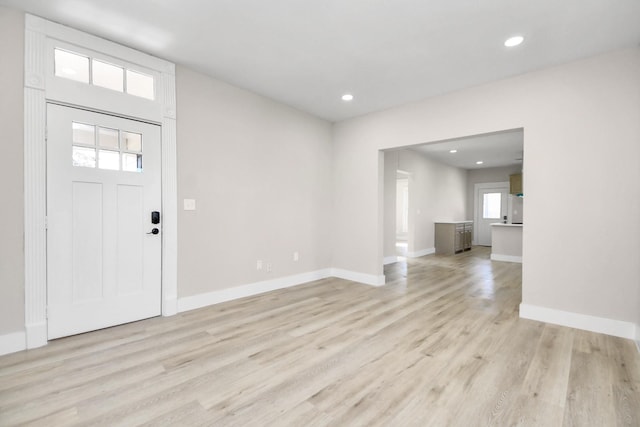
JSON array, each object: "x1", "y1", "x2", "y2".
[{"x1": 0, "y1": 7, "x2": 24, "y2": 335}]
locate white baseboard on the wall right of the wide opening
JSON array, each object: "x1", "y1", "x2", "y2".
[{"x1": 520, "y1": 303, "x2": 636, "y2": 339}]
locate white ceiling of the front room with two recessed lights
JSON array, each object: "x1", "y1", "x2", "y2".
[{"x1": 0, "y1": 0, "x2": 640, "y2": 121}]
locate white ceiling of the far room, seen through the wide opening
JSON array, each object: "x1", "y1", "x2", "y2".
[{"x1": 408, "y1": 129, "x2": 524, "y2": 169}]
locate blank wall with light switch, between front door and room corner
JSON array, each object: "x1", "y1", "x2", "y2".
[{"x1": 176, "y1": 66, "x2": 332, "y2": 297}]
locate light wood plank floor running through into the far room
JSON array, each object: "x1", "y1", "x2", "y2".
[{"x1": 0, "y1": 247, "x2": 640, "y2": 426}]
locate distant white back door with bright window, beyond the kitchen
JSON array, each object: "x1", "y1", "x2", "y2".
[{"x1": 475, "y1": 183, "x2": 509, "y2": 246}]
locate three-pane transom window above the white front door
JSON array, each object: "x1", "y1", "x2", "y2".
[{"x1": 54, "y1": 48, "x2": 155, "y2": 100}]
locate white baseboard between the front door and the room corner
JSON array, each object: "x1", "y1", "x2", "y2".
[{"x1": 178, "y1": 268, "x2": 331, "y2": 312}]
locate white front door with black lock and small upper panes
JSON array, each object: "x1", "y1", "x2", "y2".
[{"x1": 47, "y1": 104, "x2": 162, "y2": 339}]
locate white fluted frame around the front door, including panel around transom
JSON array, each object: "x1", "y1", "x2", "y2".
[{"x1": 24, "y1": 14, "x2": 178, "y2": 348}]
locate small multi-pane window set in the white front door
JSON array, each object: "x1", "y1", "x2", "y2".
[{"x1": 71, "y1": 122, "x2": 142, "y2": 172}]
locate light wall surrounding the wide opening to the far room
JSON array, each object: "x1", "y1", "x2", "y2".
[{"x1": 333, "y1": 48, "x2": 640, "y2": 322}]
